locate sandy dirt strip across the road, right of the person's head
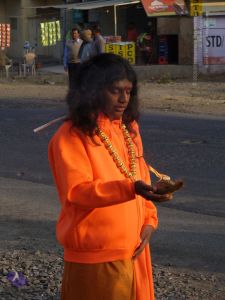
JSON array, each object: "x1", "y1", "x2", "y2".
[{"x1": 140, "y1": 81, "x2": 225, "y2": 116}]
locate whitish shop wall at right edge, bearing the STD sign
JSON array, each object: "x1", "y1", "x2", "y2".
[{"x1": 193, "y1": 0, "x2": 225, "y2": 74}]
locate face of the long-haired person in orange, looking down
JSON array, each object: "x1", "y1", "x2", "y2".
[{"x1": 103, "y1": 79, "x2": 133, "y2": 120}]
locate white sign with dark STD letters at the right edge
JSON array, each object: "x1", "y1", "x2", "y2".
[{"x1": 203, "y1": 28, "x2": 225, "y2": 65}]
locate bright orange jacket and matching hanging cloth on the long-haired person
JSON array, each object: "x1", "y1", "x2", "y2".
[{"x1": 49, "y1": 116, "x2": 157, "y2": 300}]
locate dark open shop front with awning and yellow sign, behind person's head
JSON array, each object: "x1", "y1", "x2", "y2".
[{"x1": 23, "y1": 0, "x2": 223, "y2": 74}]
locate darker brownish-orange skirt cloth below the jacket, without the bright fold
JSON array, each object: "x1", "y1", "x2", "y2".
[{"x1": 61, "y1": 260, "x2": 136, "y2": 300}]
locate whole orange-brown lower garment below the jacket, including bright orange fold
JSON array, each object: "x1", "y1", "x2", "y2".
[{"x1": 61, "y1": 247, "x2": 154, "y2": 300}]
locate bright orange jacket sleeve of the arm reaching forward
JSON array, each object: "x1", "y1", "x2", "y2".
[{"x1": 49, "y1": 127, "x2": 135, "y2": 208}]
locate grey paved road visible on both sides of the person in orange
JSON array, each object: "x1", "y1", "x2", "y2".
[{"x1": 0, "y1": 108, "x2": 225, "y2": 272}]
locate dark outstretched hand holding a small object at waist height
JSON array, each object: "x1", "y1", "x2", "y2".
[{"x1": 134, "y1": 180, "x2": 173, "y2": 202}]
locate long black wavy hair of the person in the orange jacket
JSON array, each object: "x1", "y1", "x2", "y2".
[{"x1": 66, "y1": 53, "x2": 139, "y2": 136}]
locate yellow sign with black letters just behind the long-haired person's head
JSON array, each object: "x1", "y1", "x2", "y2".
[{"x1": 105, "y1": 42, "x2": 135, "y2": 64}]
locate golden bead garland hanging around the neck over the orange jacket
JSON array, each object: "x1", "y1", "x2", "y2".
[{"x1": 96, "y1": 124, "x2": 136, "y2": 181}]
